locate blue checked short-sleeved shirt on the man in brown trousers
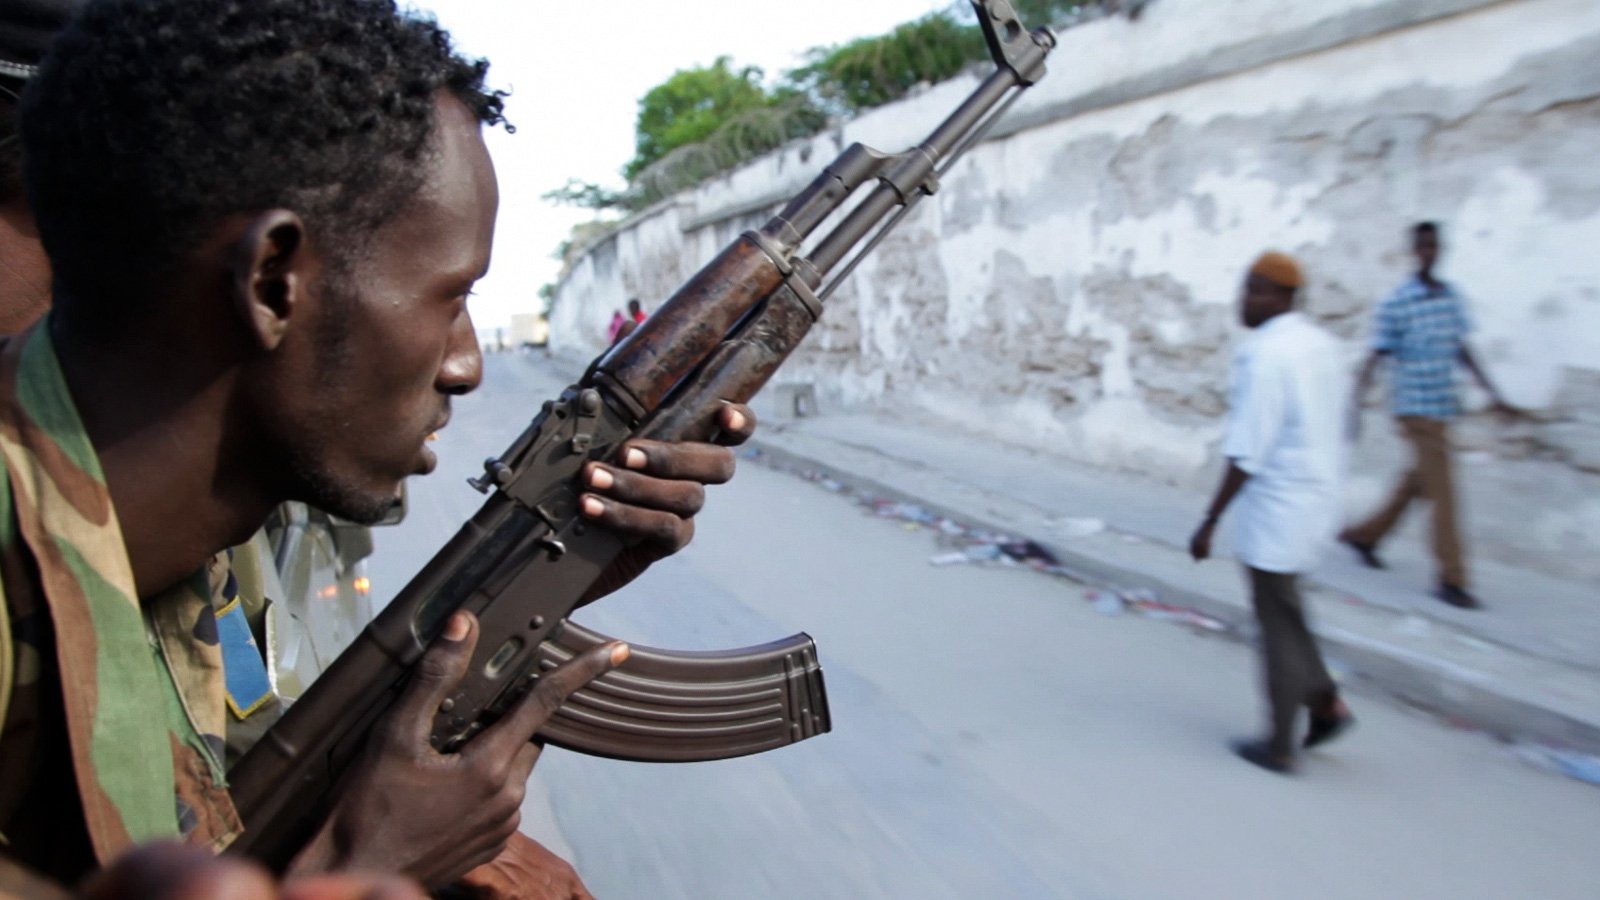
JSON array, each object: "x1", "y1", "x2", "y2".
[{"x1": 1373, "y1": 277, "x2": 1472, "y2": 418}]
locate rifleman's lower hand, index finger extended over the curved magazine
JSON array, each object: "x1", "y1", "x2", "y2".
[{"x1": 290, "y1": 612, "x2": 627, "y2": 887}]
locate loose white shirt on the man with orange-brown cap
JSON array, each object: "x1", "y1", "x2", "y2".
[{"x1": 1222, "y1": 312, "x2": 1349, "y2": 573}]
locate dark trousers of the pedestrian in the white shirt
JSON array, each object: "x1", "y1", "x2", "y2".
[{"x1": 1245, "y1": 565, "x2": 1338, "y2": 756}]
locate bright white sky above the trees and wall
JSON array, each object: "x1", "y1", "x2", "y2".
[{"x1": 413, "y1": 0, "x2": 950, "y2": 330}]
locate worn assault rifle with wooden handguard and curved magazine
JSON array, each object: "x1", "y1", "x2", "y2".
[{"x1": 229, "y1": 0, "x2": 1054, "y2": 868}]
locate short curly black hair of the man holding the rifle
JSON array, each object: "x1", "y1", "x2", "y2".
[{"x1": 21, "y1": 0, "x2": 504, "y2": 303}]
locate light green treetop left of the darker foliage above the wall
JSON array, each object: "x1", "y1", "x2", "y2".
[{"x1": 622, "y1": 56, "x2": 770, "y2": 181}]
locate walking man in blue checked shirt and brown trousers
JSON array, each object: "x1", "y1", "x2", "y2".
[{"x1": 1339, "y1": 223, "x2": 1518, "y2": 609}]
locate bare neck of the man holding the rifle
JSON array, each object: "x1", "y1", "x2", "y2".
[{"x1": 53, "y1": 312, "x2": 274, "y2": 597}]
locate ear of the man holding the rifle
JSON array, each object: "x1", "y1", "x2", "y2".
[{"x1": 230, "y1": 210, "x2": 308, "y2": 351}]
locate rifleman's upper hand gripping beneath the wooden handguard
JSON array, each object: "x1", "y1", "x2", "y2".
[{"x1": 581, "y1": 404, "x2": 755, "y2": 604}]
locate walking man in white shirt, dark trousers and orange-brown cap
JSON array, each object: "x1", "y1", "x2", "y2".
[{"x1": 1189, "y1": 253, "x2": 1355, "y2": 773}]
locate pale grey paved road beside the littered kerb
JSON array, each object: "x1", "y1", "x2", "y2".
[{"x1": 371, "y1": 356, "x2": 1600, "y2": 900}]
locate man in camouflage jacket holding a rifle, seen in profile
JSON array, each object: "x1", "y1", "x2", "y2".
[{"x1": 0, "y1": 0, "x2": 754, "y2": 895}]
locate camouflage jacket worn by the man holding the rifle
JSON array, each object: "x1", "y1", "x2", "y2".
[{"x1": 0, "y1": 319, "x2": 248, "y2": 882}]
